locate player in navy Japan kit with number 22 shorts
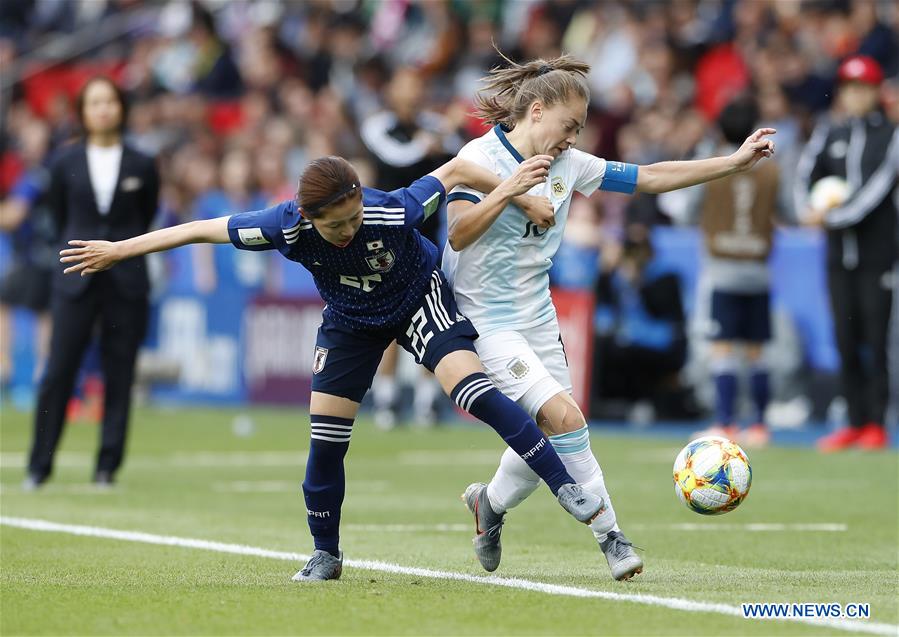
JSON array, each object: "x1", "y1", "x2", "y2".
[{"x1": 61, "y1": 156, "x2": 603, "y2": 581}]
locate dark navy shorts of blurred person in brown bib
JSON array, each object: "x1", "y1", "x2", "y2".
[{"x1": 710, "y1": 290, "x2": 771, "y2": 343}]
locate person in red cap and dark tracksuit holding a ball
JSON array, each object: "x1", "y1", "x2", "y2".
[{"x1": 796, "y1": 56, "x2": 899, "y2": 451}]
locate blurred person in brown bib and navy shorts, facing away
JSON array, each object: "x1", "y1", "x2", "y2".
[{"x1": 695, "y1": 97, "x2": 780, "y2": 447}]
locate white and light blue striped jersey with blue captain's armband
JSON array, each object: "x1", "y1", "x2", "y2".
[{"x1": 443, "y1": 125, "x2": 637, "y2": 336}]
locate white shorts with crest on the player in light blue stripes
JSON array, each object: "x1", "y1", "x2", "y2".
[{"x1": 474, "y1": 319, "x2": 571, "y2": 419}]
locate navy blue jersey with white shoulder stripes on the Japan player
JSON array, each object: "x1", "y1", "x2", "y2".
[{"x1": 228, "y1": 176, "x2": 446, "y2": 330}]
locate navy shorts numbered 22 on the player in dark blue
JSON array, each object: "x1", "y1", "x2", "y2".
[{"x1": 312, "y1": 270, "x2": 478, "y2": 403}]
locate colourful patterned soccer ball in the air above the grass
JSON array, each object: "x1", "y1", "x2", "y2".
[{"x1": 674, "y1": 436, "x2": 752, "y2": 515}]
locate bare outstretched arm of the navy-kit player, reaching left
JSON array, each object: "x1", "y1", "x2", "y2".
[{"x1": 59, "y1": 217, "x2": 230, "y2": 276}]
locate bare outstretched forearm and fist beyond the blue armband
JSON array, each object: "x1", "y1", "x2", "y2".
[{"x1": 637, "y1": 128, "x2": 777, "y2": 193}]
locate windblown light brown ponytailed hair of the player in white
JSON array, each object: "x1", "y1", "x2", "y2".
[{"x1": 475, "y1": 49, "x2": 590, "y2": 128}]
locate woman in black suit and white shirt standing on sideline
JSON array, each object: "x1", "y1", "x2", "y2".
[{"x1": 24, "y1": 77, "x2": 159, "y2": 489}]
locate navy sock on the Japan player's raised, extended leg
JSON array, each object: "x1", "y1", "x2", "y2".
[{"x1": 450, "y1": 372, "x2": 574, "y2": 493}]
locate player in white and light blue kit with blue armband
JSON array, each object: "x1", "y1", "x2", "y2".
[{"x1": 443, "y1": 56, "x2": 774, "y2": 579}]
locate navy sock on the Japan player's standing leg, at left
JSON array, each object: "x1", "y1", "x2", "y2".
[{"x1": 303, "y1": 414, "x2": 353, "y2": 557}]
